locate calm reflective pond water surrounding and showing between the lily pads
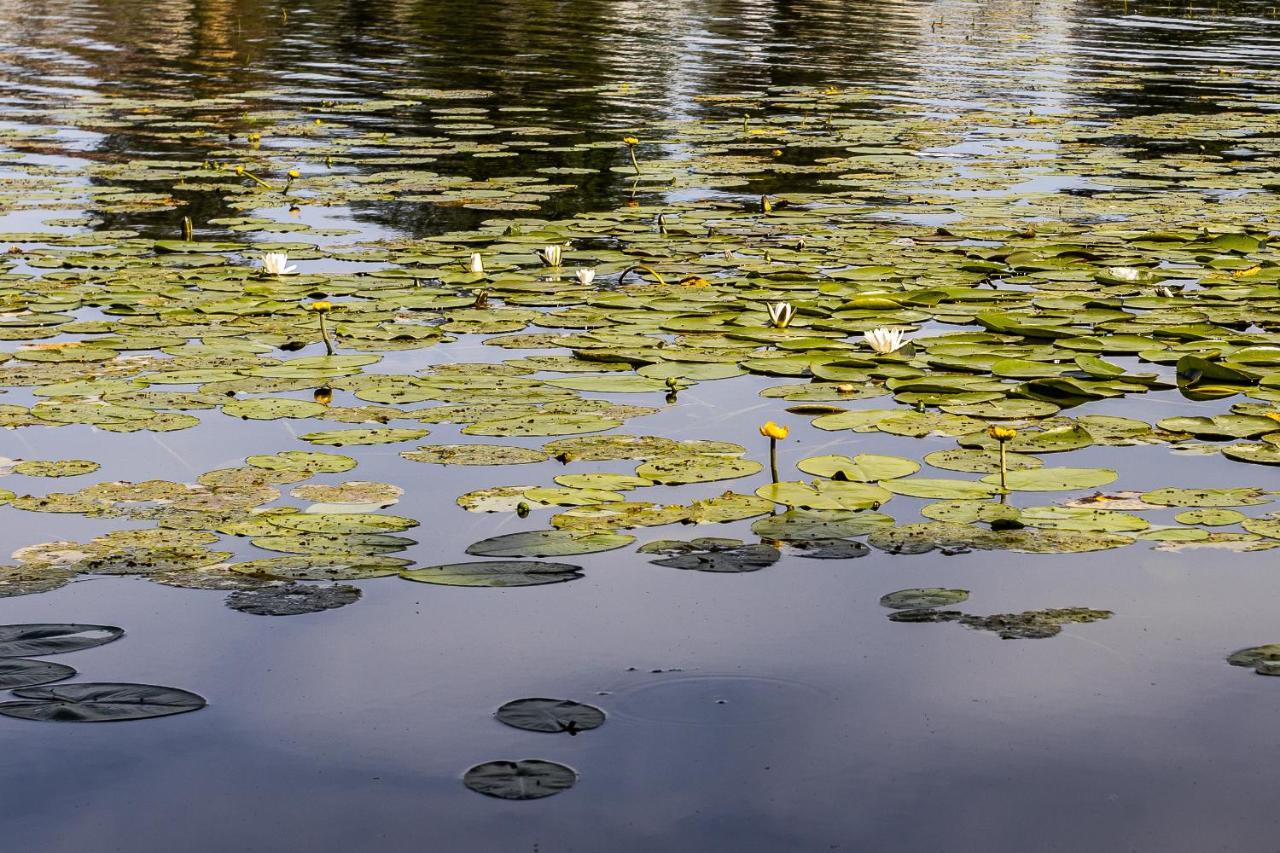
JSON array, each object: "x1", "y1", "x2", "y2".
[{"x1": 0, "y1": 0, "x2": 1280, "y2": 853}]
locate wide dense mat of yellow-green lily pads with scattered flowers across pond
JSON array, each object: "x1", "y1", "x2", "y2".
[{"x1": 0, "y1": 72, "x2": 1280, "y2": 666}]
